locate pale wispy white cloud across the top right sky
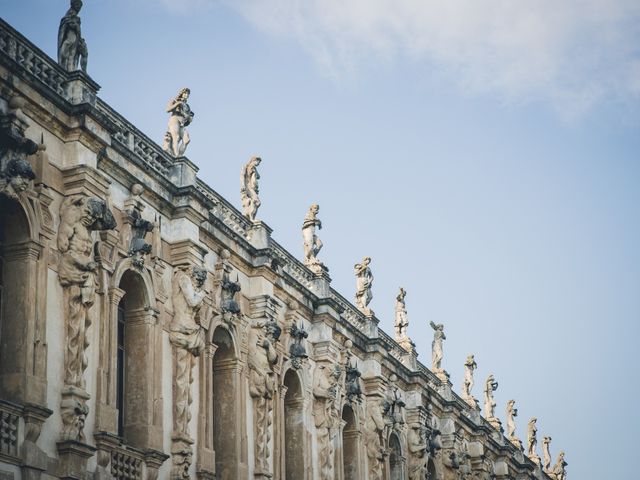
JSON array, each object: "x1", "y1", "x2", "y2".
[{"x1": 216, "y1": 0, "x2": 640, "y2": 115}]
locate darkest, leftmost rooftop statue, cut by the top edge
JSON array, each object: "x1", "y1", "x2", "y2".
[{"x1": 58, "y1": 0, "x2": 89, "y2": 73}]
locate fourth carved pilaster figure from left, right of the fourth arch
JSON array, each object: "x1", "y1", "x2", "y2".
[{"x1": 313, "y1": 363, "x2": 338, "y2": 480}]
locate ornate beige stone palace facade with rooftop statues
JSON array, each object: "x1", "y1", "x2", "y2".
[{"x1": 0, "y1": 6, "x2": 566, "y2": 480}]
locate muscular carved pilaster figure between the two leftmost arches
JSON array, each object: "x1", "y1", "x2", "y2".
[{"x1": 58, "y1": 195, "x2": 116, "y2": 441}]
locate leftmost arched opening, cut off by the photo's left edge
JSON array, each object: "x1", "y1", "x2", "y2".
[{"x1": 0, "y1": 196, "x2": 38, "y2": 403}]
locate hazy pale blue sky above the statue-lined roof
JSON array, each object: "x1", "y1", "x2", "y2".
[{"x1": 0, "y1": 0, "x2": 640, "y2": 480}]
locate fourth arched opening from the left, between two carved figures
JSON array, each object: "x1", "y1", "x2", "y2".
[{"x1": 284, "y1": 370, "x2": 305, "y2": 480}]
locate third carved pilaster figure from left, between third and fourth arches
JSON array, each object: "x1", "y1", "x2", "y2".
[{"x1": 249, "y1": 321, "x2": 281, "y2": 475}]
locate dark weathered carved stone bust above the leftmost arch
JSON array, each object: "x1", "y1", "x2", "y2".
[{"x1": 0, "y1": 97, "x2": 38, "y2": 199}]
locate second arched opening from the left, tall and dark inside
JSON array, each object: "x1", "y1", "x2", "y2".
[{"x1": 116, "y1": 270, "x2": 153, "y2": 447}]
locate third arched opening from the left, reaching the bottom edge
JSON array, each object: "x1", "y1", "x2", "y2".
[{"x1": 213, "y1": 327, "x2": 241, "y2": 480}]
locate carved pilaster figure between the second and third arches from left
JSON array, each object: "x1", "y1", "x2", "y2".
[{"x1": 169, "y1": 266, "x2": 207, "y2": 479}]
